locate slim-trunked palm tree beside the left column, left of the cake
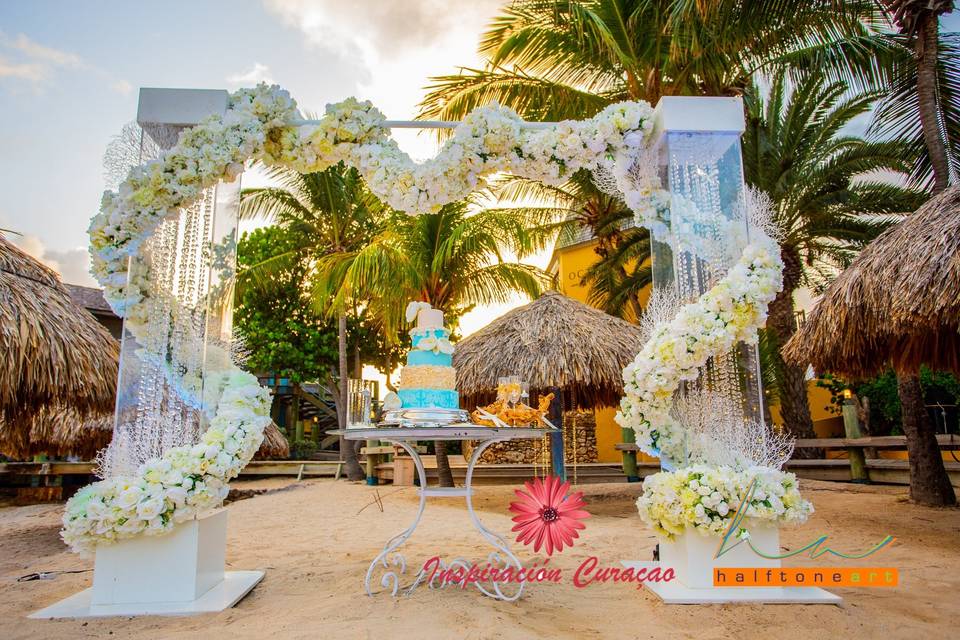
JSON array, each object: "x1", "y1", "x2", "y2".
[{"x1": 240, "y1": 165, "x2": 387, "y2": 480}]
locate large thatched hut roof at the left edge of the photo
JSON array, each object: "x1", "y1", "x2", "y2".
[{"x1": 0, "y1": 235, "x2": 119, "y2": 457}]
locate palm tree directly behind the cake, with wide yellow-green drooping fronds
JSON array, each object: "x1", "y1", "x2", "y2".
[{"x1": 314, "y1": 202, "x2": 551, "y2": 487}]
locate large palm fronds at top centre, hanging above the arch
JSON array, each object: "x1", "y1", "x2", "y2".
[{"x1": 421, "y1": 0, "x2": 885, "y2": 120}]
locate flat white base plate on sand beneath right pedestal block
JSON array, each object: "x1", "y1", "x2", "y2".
[{"x1": 620, "y1": 560, "x2": 843, "y2": 605}]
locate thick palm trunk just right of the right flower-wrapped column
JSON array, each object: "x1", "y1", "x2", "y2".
[{"x1": 767, "y1": 251, "x2": 819, "y2": 448}]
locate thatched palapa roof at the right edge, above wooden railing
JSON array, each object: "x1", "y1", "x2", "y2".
[{"x1": 784, "y1": 187, "x2": 960, "y2": 377}]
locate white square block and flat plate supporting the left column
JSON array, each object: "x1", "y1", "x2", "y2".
[{"x1": 30, "y1": 509, "x2": 263, "y2": 618}]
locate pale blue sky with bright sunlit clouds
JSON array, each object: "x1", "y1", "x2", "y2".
[{"x1": 0, "y1": 0, "x2": 960, "y2": 333}]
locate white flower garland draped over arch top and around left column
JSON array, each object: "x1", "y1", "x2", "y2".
[{"x1": 62, "y1": 84, "x2": 652, "y2": 551}]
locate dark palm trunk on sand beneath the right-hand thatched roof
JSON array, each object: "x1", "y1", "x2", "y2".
[{"x1": 897, "y1": 372, "x2": 957, "y2": 507}]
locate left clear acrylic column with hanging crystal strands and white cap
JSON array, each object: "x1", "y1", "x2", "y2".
[{"x1": 100, "y1": 89, "x2": 240, "y2": 477}]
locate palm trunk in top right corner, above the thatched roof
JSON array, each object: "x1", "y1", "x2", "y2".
[{"x1": 913, "y1": 11, "x2": 950, "y2": 195}]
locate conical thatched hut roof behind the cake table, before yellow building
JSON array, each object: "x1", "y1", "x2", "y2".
[{"x1": 453, "y1": 291, "x2": 643, "y2": 408}]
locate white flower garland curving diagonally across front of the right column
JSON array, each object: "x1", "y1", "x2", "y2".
[{"x1": 616, "y1": 233, "x2": 783, "y2": 461}]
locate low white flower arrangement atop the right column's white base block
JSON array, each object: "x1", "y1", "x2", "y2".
[{"x1": 637, "y1": 464, "x2": 813, "y2": 540}]
